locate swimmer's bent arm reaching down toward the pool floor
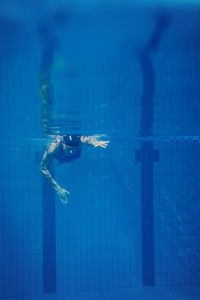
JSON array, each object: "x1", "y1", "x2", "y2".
[{"x1": 40, "y1": 141, "x2": 69, "y2": 204}]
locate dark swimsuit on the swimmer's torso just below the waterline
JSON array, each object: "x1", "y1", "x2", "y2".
[{"x1": 55, "y1": 138, "x2": 82, "y2": 163}]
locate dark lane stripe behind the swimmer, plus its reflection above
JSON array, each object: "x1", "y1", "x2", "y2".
[{"x1": 39, "y1": 19, "x2": 57, "y2": 293}]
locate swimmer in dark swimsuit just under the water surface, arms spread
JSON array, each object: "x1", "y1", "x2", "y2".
[{"x1": 40, "y1": 135, "x2": 109, "y2": 204}]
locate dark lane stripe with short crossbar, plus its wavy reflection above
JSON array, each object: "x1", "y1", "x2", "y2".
[{"x1": 136, "y1": 12, "x2": 169, "y2": 286}]
